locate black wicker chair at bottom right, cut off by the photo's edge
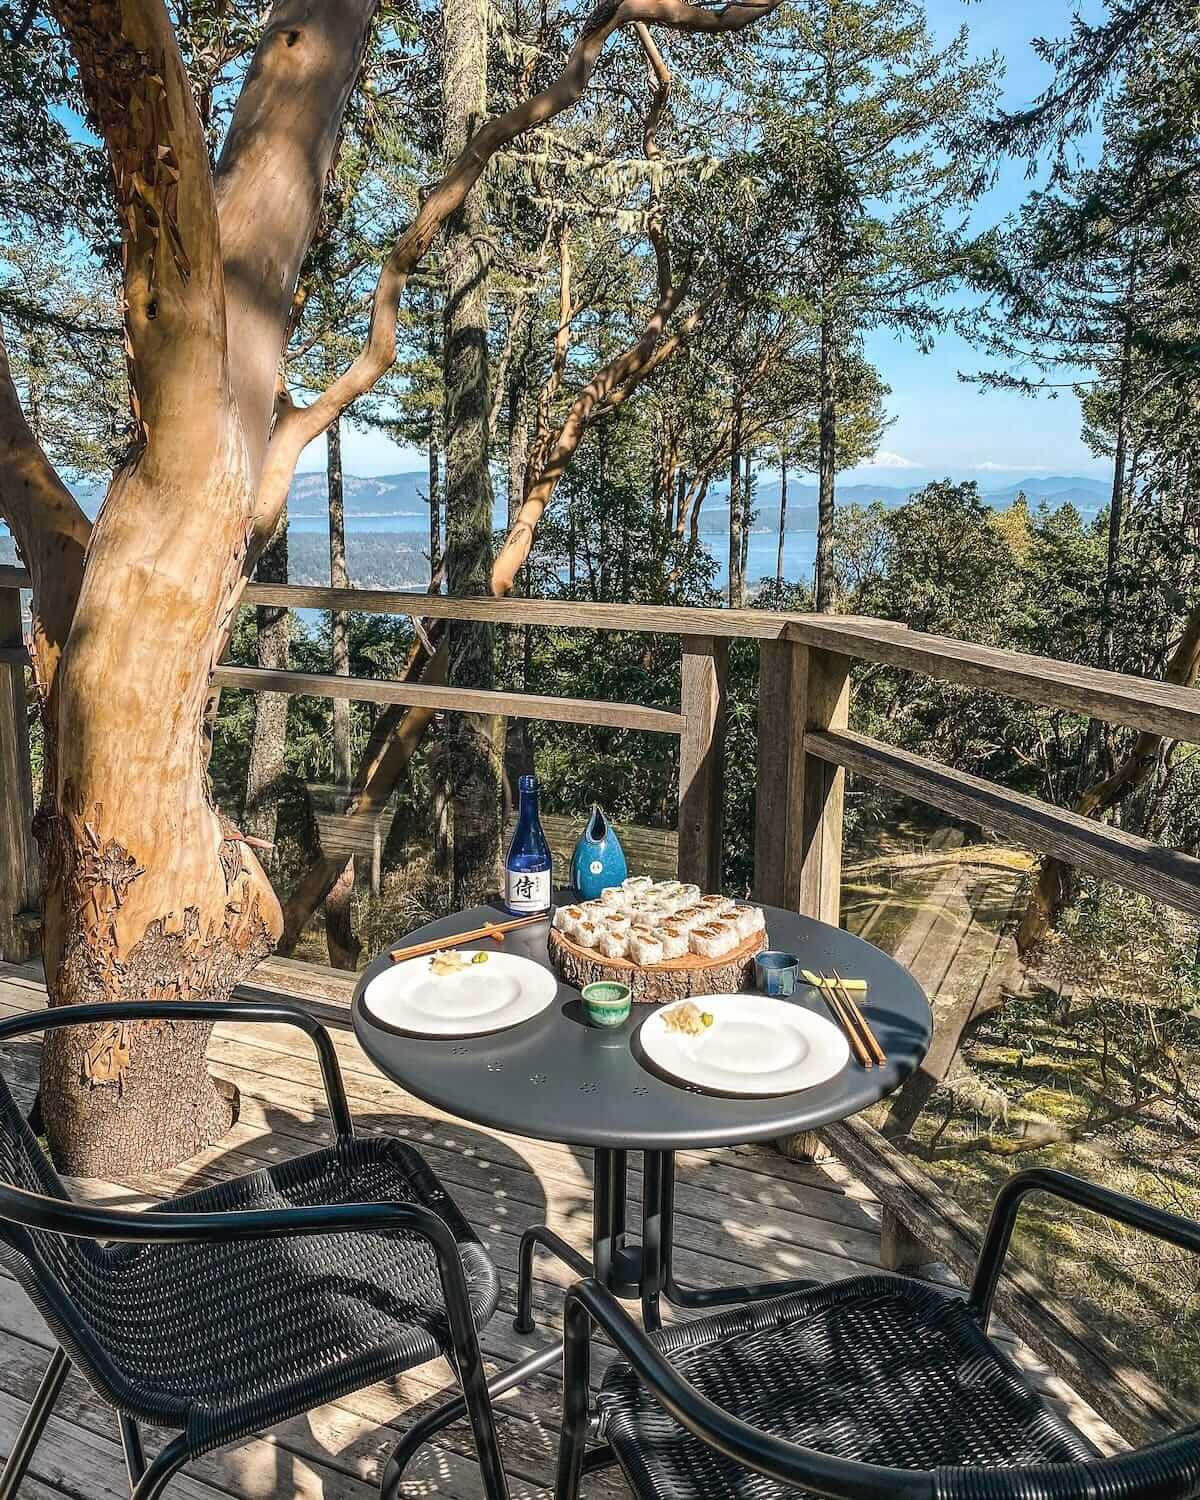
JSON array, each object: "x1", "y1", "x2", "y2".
[{"x1": 557, "y1": 1170, "x2": 1200, "y2": 1500}]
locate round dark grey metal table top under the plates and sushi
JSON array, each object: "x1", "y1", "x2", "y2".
[{"x1": 354, "y1": 906, "x2": 933, "y2": 1151}]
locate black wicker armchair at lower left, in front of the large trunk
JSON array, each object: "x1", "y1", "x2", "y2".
[{"x1": 0, "y1": 1001, "x2": 507, "y2": 1500}]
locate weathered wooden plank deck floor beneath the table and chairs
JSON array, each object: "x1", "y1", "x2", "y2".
[{"x1": 0, "y1": 965, "x2": 1121, "y2": 1500}]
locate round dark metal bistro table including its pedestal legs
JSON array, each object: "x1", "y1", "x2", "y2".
[{"x1": 354, "y1": 906, "x2": 933, "y2": 1493}]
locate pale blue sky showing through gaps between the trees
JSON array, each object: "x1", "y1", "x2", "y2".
[{"x1": 309, "y1": 0, "x2": 1109, "y2": 486}]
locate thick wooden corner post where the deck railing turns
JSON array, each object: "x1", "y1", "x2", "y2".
[{"x1": 755, "y1": 641, "x2": 851, "y2": 924}]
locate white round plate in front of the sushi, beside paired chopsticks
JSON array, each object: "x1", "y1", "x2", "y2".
[{"x1": 639, "y1": 995, "x2": 851, "y2": 1095}]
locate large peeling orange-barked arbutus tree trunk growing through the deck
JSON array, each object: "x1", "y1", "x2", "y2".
[{"x1": 0, "y1": 0, "x2": 773, "y2": 1178}]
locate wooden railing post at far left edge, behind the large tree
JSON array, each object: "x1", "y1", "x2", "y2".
[{"x1": 0, "y1": 588, "x2": 39, "y2": 963}]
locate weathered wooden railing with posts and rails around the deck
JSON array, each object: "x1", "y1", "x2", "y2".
[{"x1": 0, "y1": 567, "x2": 1200, "y2": 1434}]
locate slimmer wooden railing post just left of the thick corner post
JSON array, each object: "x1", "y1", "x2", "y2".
[{"x1": 680, "y1": 636, "x2": 729, "y2": 891}]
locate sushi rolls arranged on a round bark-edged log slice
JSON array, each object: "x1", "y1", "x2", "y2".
[{"x1": 549, "y1": 876, "x2": 767, "y2": 1004}]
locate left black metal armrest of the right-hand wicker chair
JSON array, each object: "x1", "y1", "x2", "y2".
[{"x1": 555, "y1": 1278, "x2": 935, "y2": 1500}]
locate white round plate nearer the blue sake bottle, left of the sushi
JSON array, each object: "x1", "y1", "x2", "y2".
[{"x1": 363, "y1": 948, "x2": 558, "y2": 1037}]
